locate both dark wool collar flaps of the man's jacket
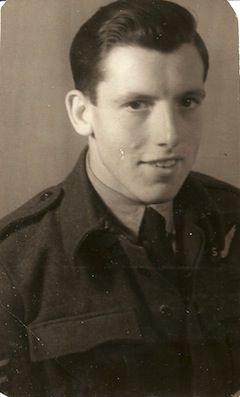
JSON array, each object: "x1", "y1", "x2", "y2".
[{"x1": 59, "y1": 147, "x2": 224, "y2": 260}]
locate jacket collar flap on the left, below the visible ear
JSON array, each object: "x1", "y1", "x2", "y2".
[{"x1": 59, "y1": 147, "x2": 113, "y2": 260}]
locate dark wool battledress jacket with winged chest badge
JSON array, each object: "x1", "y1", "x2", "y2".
[{"x1": 0, "y1": 148, "x2": 240, "y2": 397}]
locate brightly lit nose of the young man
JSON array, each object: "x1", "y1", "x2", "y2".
[{"x1": 151, "y1": 102, "x2": 179, "y2": 149}]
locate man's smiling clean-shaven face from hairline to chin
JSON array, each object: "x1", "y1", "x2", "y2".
[{"x1": 86, "y1": 44, "x2": 204, "y2": 203}]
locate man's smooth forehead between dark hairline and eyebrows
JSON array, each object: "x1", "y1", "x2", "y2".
[{"x1": 99, "y1": 44, "x2": 204, "y2": 93}]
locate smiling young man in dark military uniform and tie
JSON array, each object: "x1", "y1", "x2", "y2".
[{"x1": 0, "y1": 0, "x2": 240, "y2": 397}]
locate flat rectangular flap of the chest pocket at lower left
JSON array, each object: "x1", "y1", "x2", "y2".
[{"x1": 28, "y1": 311, "x2": 142, "y2": 361}]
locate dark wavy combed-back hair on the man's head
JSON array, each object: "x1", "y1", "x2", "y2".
[{"x1": 70, "y1": 0, "x2": 209, "y2": 102}]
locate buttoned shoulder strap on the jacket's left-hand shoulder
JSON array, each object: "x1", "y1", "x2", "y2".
[{"x1": 0, "y1": 185, "x2": 63, "y2": 243}]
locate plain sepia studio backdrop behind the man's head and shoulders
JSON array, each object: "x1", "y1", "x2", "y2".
[{"x1": 0, "y1": 0, "x2": 240, "y2": 217}]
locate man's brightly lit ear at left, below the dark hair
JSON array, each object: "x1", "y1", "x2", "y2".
[{"x1": 65, "y1": 90, "x2": 93, "y2": 136}]
